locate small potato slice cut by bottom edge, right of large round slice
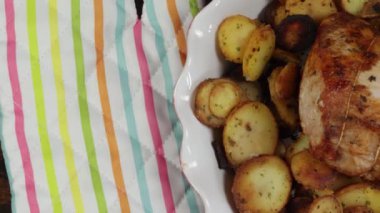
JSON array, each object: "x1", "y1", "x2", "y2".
[{"x1": 309, "y1": 196, "x2": 343, "y2": 213}]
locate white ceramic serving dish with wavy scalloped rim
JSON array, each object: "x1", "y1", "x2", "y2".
[{"x1": 174, "y1": 0, "x2": 268, "y2": 213}]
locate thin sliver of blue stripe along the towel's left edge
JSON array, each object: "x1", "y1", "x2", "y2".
[{"x1": 0, "y1": 105, "x2": 17, "y2": 212}]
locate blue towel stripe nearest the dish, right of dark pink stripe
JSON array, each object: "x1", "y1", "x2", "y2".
[{"x1": 145, "y1": 0, "x2": 199, "y2": 213}]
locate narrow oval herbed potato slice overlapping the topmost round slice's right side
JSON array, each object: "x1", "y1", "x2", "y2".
[{"x1": 243, "y1": 25, "x2": 276, "y2": 81}]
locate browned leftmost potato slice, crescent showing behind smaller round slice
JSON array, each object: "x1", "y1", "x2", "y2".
[{"x1": 194, "y1": 79, "x2": 225, "y2": 128}]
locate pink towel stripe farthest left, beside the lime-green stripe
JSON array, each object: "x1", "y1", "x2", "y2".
[{"x1": 5, "y1": 0, "x2": 40, "y2": 213}]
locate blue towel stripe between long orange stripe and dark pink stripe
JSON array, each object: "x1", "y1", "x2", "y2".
[{"x1": 115, "y1": 0, "x2": 153, "y2": 212}]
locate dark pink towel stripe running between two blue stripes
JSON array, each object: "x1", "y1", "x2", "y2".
[{"x1": 133, "y1": 20, "x2": 175, "y2": 212}]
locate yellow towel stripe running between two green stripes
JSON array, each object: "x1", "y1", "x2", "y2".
[{"x1": 49, "y1": 0, "x2": 84, "y2": 212}]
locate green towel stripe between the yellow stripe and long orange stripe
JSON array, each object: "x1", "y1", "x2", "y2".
[{"x1": 71, "y1": 0, "x2": 107, "y2": 213}]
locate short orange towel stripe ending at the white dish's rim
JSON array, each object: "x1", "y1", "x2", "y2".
[{"x1": 167, "y1": 0, "x2": 187, "y2": 64}]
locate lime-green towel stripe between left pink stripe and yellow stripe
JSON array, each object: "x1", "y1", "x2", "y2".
[{"x1": 27, "y1": 0, "x2": 62, "y2": 212}]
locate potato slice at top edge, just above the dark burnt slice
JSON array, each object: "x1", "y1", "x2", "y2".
[{"x1": 285, "y1": 0, "x2": 337, "y2": 22}]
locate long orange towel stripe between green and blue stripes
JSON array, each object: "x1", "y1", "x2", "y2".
[{"x1": 94, "y1": 0, "x2": 130, "y2": 212}]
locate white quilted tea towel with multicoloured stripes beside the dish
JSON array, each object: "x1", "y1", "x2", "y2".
[{"x1": 0, "y1": 0, "x2": 203, "y2": 213}]
